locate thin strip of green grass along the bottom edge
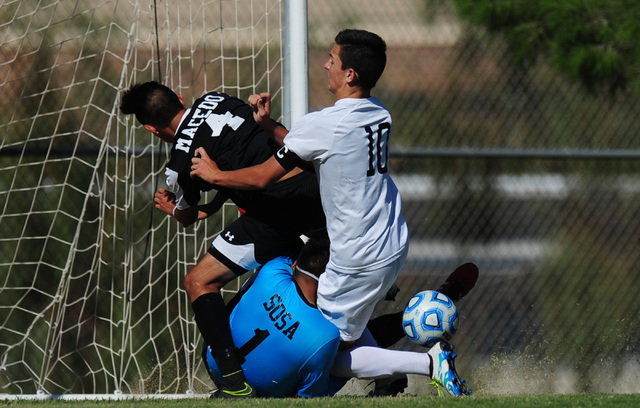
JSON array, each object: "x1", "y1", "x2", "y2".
[{"x1": 0, "y1": 394, "x2": 640, "y2": 408}]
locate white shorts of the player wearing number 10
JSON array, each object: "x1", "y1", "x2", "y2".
[{"x1": 317, "y1": 245, "x2": 408, "y2": 341}]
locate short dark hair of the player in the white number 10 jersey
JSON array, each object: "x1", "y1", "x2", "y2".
[{"x1": 335, "y1": 29, "x2": 387, "y2": 89}]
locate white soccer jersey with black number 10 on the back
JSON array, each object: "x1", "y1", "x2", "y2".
[{"x1": 284, "y1": 98, "x2": 409, "y2": 273}]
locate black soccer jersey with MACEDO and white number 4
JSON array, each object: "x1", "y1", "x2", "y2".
[{"x1": 167, "y1": 92, "x2": 325, "y2": 231}]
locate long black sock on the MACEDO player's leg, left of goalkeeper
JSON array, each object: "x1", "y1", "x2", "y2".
[{"x1": 191, "y1": 293, "x2": 246, "y2": 390}]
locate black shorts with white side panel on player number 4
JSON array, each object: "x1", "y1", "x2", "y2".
[{"x1": 208, "y1": 215, "x2": 304, "y2": 275}]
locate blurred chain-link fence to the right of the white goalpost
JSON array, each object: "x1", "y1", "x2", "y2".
[{"x1": 309, "y1": 0, "x2": 640, "y2": 393}]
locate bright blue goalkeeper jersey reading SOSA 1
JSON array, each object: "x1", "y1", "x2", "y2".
[{"x1": 206, "y1": 257, "x2": 340, "y2": 397}]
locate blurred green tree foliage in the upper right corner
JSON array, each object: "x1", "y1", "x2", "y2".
[{"x1": 454, "y1": 0, "x2": 640, "y2": 93}]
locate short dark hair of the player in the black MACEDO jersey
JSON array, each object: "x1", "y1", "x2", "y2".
[{"x1": 120, "y1": 81, "x2": 184, "y2": 127}]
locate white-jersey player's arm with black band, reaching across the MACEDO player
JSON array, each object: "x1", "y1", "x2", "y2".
[{"x1": 191, "y1": 146, "x2": 300, "y2": 190}]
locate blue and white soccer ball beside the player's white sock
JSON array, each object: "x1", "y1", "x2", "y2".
[{"x1": 402, "y1": 290, "x2": 459, "y2": 347}]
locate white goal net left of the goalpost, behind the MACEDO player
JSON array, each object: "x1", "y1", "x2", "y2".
[{"x1": 0, "y1": 0, "x2": 294, "y2": 395}]
